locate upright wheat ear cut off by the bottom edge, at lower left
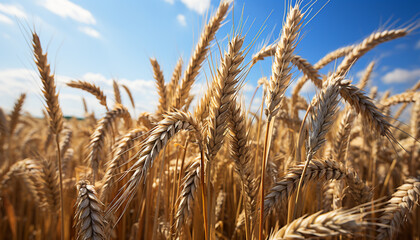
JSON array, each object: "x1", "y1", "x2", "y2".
[{"x1": 74, "y1": 180, "x2": 107, "y2": 240}]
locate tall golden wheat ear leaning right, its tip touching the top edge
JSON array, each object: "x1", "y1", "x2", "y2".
[{"x1": 174, "y1": 1, "x2": 230, "y2": 109}]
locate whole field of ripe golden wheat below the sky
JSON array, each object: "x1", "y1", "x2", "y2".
[{"x1": 0, "y1": 2, "x2": 420, "y2": 240}]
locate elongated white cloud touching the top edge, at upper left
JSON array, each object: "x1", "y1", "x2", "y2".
[{"x1": 40, "y1": 0, "x2": 96, "y2": 24}]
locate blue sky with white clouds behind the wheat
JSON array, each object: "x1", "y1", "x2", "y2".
[{"x1": 0, "y1": 0, "x2": 420, "y2": 116}]
